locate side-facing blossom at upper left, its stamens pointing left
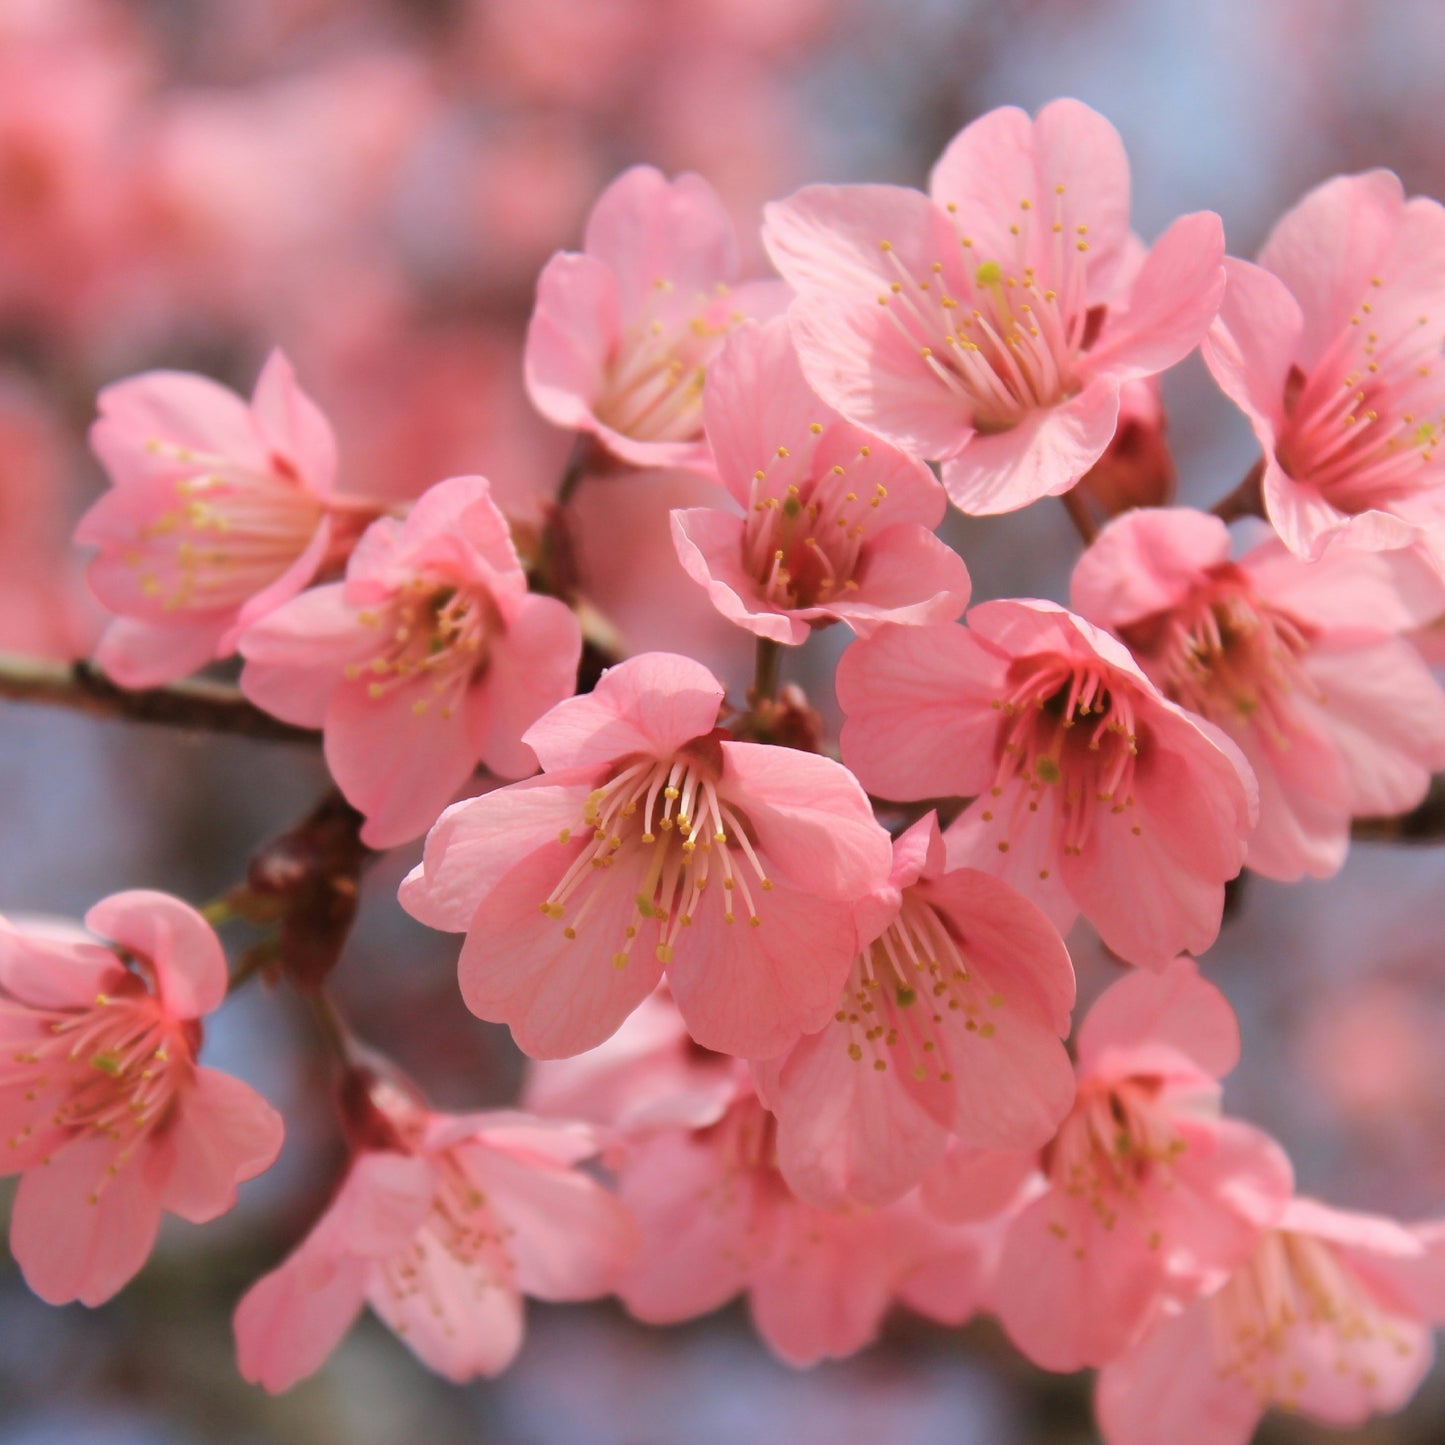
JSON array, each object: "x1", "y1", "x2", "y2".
[{"x1": 75, "y1": 351, "x2": 376, "y2": 688}]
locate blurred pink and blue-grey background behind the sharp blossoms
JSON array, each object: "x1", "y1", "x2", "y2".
[{"x1": 0, "y1": 0, "x2": 1445, "y2": 1445}]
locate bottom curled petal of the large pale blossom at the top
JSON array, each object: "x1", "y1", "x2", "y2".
[{"x1": 942, "y1": 377, "x2": 1118, "y2": 516}]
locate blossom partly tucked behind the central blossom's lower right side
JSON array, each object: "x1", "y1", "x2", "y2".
[{"x1": 753, "y1": 814, "x2": 1074, "y2": 1207}]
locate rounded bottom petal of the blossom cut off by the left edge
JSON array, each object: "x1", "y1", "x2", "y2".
[{"x1": 10, "y1": 1137, "x2": 160, "y2": 1305}]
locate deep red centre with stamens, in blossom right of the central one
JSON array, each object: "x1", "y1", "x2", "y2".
[{"x1": 981, "y1": 655, "x2": 1140, "y2": 879}]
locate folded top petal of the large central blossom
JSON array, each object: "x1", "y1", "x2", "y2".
[{"x1": 525, "y1": 652, "x2": 724, "y2": 772}]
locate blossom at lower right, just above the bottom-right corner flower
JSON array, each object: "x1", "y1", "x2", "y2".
[{"x1": 996, "y1": 958, "x2": 1293, "y2": 1370}]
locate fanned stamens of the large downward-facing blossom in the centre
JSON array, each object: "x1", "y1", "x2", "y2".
[{"x1": 542, "y1": 751, "x2": 773, "y2": 968}]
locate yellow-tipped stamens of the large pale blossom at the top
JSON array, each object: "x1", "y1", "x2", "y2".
[{"x1": 879, "y1": 186, "x2": 1103, "y2": 432}]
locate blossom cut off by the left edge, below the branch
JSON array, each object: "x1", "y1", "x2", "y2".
[{"x1": 0, "y1": 892, "x2": 282, "y2": 1305}]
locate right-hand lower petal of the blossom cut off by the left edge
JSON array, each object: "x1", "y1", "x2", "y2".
[{"x1": 160, "y1": 1068, "x2": 285, "y2": 1224}]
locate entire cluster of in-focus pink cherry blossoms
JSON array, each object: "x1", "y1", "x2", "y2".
[{"x1": 0, "y1": 100, "x2": 1445, "y2": 1445}]
